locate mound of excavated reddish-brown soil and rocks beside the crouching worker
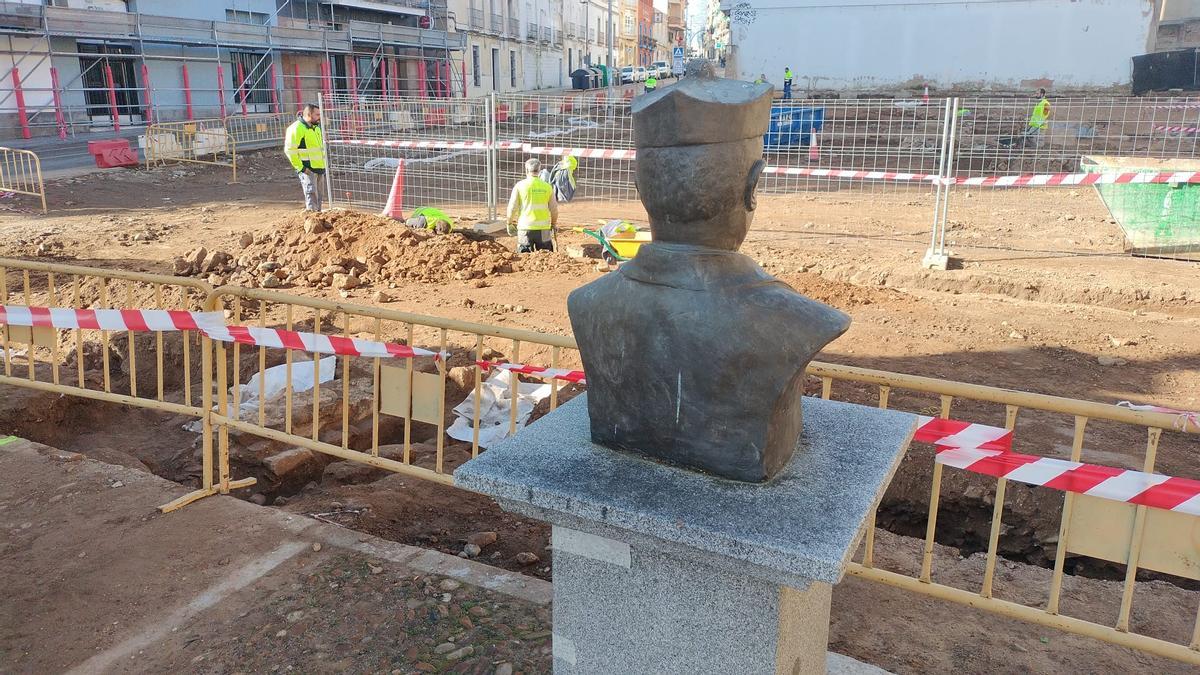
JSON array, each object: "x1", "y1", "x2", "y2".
[{"x1": 176, "y1": 211, "x2": 587, "y2": 289}]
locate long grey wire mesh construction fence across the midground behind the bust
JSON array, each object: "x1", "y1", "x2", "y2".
[{"x1": 323, "y1": 93, "x2": 1200, "y2": 261}]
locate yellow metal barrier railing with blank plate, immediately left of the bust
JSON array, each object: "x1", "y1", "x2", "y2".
[{"x1": 206, "y1": 287, "x2": 574, "y2": 494}]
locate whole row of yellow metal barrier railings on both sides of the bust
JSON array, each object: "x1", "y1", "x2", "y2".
[{"x1": 0, "y1": 259, "x2": 1200, "y2": 664}]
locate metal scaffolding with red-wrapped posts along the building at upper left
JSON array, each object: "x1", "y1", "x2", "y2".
[{"x1": 0, "y1": 0, "x2": 467, "y2": 138}]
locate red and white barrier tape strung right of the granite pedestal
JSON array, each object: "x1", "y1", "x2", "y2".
[{"x1": 913, "y1": 417, "x2": 1200, "y2": 515}]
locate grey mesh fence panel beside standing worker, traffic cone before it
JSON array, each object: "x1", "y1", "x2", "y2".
[{"x1": 322, "y1": 94, "x2": 490, "y2": 213}]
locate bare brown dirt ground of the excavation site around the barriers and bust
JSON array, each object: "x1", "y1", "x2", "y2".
[{"x1": 0, "y1": 156, "x2": 1200, "y2": 671}]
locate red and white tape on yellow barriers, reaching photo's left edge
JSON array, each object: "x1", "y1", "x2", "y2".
[{"x1": 0, "y1": 305, "x2": 443, "y2": 359}]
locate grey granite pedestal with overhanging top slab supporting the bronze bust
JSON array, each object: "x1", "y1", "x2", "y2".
[{"x1": 455, "y1": 396, "x2": 916, "y2": 674}]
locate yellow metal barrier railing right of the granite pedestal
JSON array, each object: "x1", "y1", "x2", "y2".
[{"x1": 809, "y1": 363, "x2": 1200, "y2": 665}]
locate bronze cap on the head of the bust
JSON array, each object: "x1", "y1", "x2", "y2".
[{"x1": 632, "y1": 59, "x2": 773, "y2": 148}]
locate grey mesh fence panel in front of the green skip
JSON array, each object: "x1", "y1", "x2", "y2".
[{"x1": 952, "y1": 97, "x2": 1200, "y2": 259}]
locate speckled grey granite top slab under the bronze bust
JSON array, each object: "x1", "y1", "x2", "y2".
[{"x1": 454, "y1": 394, "x2": 917, "y2": 584}]
